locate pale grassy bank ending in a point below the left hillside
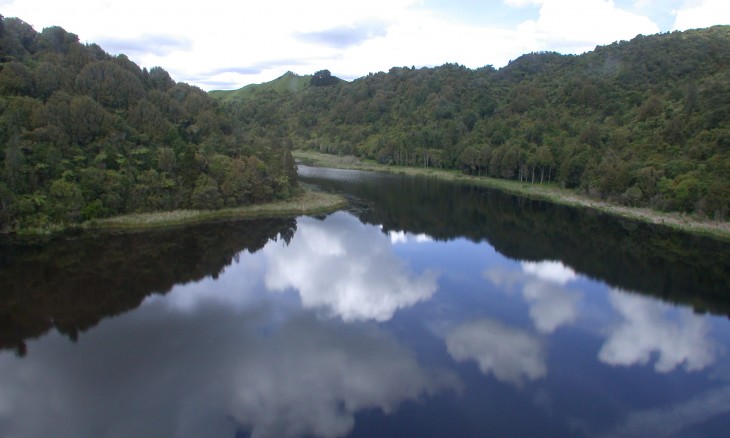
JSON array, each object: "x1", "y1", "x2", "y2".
[{"x1": 81, "y1": 190, "x2": 347, "y2": 230}]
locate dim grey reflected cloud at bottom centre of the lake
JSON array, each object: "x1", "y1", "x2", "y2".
[{"x1": 225, "y1": 314, "x2": 459, "y2": 438}]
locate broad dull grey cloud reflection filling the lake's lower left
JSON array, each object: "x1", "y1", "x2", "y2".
[{"x1": 0, "y1": 306, "x2": 461, "y2": 438}]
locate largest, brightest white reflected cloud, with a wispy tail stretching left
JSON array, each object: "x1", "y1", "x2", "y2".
[{"x1": 145, "y1": 214, "x2": 437, "y2": 321}]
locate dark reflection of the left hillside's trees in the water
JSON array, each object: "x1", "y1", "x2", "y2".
[{"x1": 0, "y1": 219, "x2": 296, "y2": 355}]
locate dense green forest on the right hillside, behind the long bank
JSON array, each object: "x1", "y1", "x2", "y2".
[{"x1": 213, "y1": 26, "x2": 730, "y2": 220}]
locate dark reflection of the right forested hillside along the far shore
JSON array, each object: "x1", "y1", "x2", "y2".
[{"x1": 302, "y1": 171, "x2": 730, "y2": 315}]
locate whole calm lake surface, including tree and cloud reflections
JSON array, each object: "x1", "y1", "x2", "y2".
[{"x1": 0, "y1": 166, "x2": 730, "y2": 437}]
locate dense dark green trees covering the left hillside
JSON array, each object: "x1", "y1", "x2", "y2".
[{"x1": 0, "y1": 16, "x2": 298, "y2": 231}]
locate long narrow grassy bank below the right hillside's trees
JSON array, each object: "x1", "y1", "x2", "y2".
[{"x1": 292, "y1": 150, "x2": 730, "y2": 240}]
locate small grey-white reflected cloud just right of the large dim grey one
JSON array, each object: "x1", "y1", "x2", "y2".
[{"x1": 446, "y1": 319, "x2": 547, "y2": 385}]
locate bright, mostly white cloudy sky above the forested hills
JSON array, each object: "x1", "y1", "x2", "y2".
[{"x1": 0, "y1": 0, "x2": 730, "y2": 90}]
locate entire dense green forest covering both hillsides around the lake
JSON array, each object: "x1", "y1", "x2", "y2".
[{"x1": 0, "y1": 16, "x2": 730, "y2": 231}]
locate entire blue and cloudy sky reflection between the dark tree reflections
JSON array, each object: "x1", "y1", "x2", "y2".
[{"x1": 0, "y1": 212, "x2": 730, "y2": 437}]
